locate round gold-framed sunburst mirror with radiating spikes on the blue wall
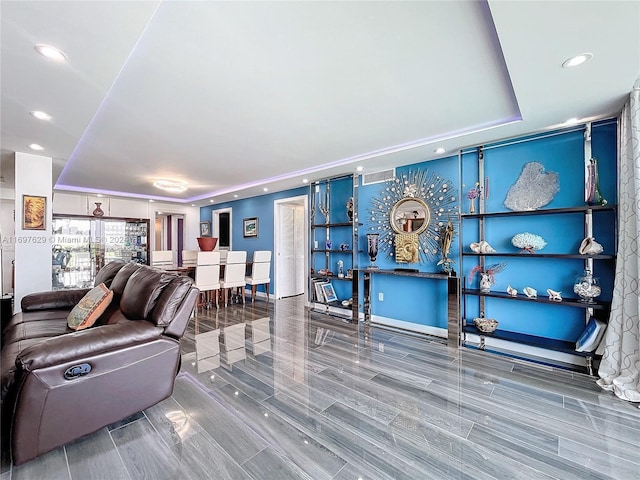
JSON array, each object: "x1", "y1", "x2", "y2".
[{"x1": 367, "y1": 170, "x2": 458, "y2": 263}]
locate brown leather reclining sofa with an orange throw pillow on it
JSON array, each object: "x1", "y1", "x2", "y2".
[{"x1": 1, "y1": 262, "x2": 199, "y2": 465}]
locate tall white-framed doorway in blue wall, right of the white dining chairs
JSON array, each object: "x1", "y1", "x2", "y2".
[{"x1": 273, "y1": 195, "x2": 309, "y2": 299}]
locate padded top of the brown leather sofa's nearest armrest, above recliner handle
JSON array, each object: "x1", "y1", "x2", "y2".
[{"x1": 16, "y1": 320, "x2": 163, "y2": 372}]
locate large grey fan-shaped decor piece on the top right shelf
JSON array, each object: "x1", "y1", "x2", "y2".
[{"x1": 504, "y1": 162, "x2": 560, "y2": 212}]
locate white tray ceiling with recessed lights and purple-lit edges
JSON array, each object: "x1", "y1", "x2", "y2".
[{"x1": 0, "y1": 1, "x2": 640, "y2": 205}]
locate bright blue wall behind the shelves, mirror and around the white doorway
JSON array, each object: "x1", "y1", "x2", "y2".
[{"x1": 200, "y1": 120, "x2": 617, "y2": 341}]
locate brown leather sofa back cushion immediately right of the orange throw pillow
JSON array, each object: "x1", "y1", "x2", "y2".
[{"x1": 120, "y1": 267, "x2": 175, "y2": 320}]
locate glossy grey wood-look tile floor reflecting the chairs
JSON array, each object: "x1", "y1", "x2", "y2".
[{"x1": 0, "y1": 297, "x2": 640, "y2": 480}]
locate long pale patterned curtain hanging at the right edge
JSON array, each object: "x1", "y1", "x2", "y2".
[{"x1": 597, "y1": 78, "x2": 640, "y2": 402}]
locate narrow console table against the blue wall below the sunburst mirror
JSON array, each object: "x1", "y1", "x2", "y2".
[{"x1": 360, "y1": 268, "x2": 461, "y2": 347}]
